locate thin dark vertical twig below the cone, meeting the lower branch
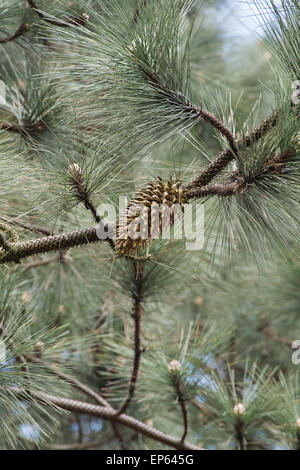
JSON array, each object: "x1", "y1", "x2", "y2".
[{"x1": 116, "y1": 261, "x2": 144, "y2": 415}]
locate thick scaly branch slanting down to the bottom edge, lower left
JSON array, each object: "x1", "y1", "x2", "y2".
[{"x1": 10, "y1": 388, "x2": 204, "y2": 450}]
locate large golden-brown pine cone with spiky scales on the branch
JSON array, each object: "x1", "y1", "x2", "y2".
[{"x1": 115, "y1": 177, "x2": 186, "y2": 256}]
